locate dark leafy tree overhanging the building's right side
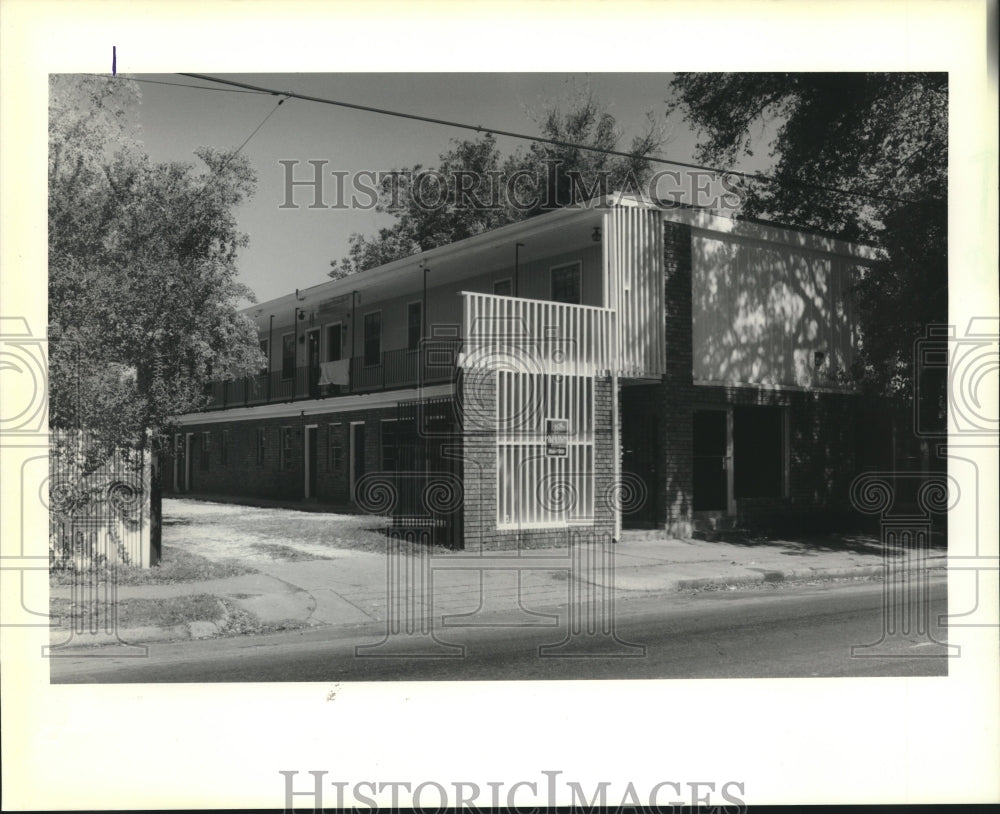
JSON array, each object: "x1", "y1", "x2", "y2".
[{"x1": 668, "y1": 73, "x2": 948, "y2": 410}]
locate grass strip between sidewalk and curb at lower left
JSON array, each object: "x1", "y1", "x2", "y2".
[{"x1": 49, "y1": 594, "x2": 226, "y2": 630}]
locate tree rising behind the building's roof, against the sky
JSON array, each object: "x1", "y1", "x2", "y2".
[{"x1": 329, "y1": 91, "x2": 664, "y2": 278}]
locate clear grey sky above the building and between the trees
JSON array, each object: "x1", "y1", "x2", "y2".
[{"x1": 133, "y1": 73, "x2": 766, "y2": 302}]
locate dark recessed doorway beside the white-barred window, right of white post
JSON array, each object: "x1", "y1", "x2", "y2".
[{"x1": 620, "y1": 385, "x2": 664, "y2": 529}]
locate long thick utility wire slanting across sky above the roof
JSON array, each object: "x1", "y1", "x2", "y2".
[{"x1": 181, "y1": 73, "x2": 942, "y2": 210}]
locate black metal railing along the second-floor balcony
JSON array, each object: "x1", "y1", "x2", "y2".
[{"x1": 205, "y1": 339, "x2": 461, "y2": 410}]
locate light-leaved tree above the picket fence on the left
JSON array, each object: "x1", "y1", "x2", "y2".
[{"x1": 49, "y1": 76, "x2": 262, "y2": 468}]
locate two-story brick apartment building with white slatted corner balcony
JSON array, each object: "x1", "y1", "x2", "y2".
[{"x1": 163, "y1": 196, "x2": 879, "y2": 549}]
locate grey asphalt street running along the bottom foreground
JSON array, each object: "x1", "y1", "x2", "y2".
[{"x1": 51, "y1": 580, "x2": 949, "y2": 683}]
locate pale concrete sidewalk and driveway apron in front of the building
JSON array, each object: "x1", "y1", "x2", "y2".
[{"x1": 50, "y1": 532, "x2": 946, "y2": 647}]
